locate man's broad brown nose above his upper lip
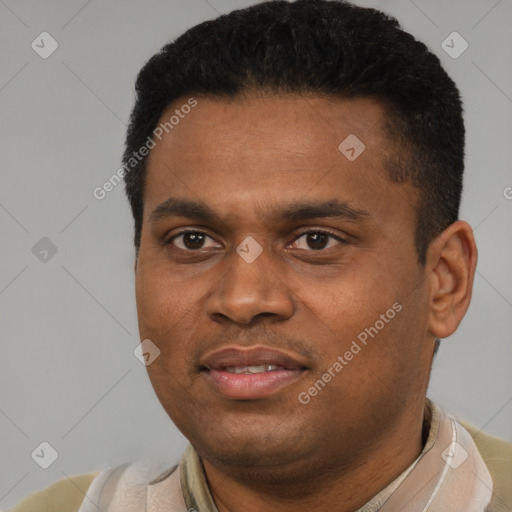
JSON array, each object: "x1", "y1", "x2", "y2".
[{"x1": 207, "y1": 247, "x2": 295, "y2": 324}]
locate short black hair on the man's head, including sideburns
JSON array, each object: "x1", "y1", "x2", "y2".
[{"x1": 123, "y1": 0, "x2": 465, "y2": 264}]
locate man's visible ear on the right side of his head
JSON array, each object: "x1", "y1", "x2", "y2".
[{"x1": 427, "y1": 220, "x2": 477, "y2": 338}]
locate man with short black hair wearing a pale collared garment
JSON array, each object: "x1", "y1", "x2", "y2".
[{"x1": 9, "y1": 0, "x2": 512, "y2": 512}]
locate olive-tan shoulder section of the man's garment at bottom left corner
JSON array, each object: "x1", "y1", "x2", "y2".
[{"x1": 7, "y1": 471, "x2": 100, "y2": 512}]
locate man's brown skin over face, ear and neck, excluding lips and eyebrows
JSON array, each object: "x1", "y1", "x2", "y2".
[{"x1": 136, "y1": 94, "x2": 476, "y2": 512}]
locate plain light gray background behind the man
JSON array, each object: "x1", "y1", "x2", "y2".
[{"x1": 0, "y1": 0, "x2": 512, "y2": 508}]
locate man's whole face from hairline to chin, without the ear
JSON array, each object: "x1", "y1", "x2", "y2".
[{"x1": 136, "y1": 96, "x2": 432, "y2": 478}]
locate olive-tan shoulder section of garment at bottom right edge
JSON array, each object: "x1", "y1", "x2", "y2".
[{"x1": 460, "y1": 421, "x2": 512, "y2": 510}]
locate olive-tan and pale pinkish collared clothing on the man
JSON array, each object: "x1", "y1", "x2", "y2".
[{"x1": 9, "y1": 401, "x2": 512, "y2": 512}]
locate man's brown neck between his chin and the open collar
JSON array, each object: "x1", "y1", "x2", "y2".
[{"x1": 203, "y1": 404, "x2": 424, "y2": 512}]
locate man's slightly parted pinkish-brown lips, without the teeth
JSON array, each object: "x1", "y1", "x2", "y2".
[{"x1": 200, "y1": 347, "x2": 308, "y2": 400}]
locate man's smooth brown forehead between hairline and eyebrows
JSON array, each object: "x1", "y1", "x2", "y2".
[{"x1": 144, "y1": 96, "x2": 416, "y2": 226}]
